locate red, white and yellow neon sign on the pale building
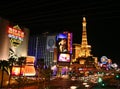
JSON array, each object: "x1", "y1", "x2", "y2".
[{"x1": 7, "y1": 25, "x2": 24, "y2": 47}]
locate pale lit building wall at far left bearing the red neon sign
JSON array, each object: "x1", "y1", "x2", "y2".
[{"x1": 0, "y1": 18, "x2": 29, "y2": 60}]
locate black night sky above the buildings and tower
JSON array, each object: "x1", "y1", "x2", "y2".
[{"x1": 0, "y1": 0, "x2": 120, "y2": 62}]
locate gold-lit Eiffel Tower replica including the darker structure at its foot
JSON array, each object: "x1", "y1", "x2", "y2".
[{"x1": 72, "y1": 17, "x2": 97, "y2": 69}]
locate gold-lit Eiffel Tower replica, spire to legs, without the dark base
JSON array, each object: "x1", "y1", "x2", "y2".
[{"x1": 79, "y1": 17, "x2": 91, "y2": 57}]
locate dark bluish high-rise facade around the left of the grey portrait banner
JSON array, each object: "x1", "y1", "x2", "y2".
[{"x1": 28, "y1": 35, "x2": 54, "y2": 66}]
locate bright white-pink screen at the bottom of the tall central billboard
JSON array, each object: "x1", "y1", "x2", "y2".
[{"x1": 58, "y1": 53, "x2": 70, "y2": 62}]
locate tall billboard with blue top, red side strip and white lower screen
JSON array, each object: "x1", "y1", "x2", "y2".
[{"x1": 56, "y1": 32, "x2": 72, "y2": 66}]
